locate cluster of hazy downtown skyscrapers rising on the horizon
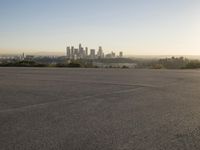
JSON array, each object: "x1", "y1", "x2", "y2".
[{"x1": 66, "y1": 44, "x2": 123, "y2": 59}]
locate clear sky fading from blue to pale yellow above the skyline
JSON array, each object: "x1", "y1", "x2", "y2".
[{"x1": 0, "y1": 0, "x2": 200, "y2": 55}]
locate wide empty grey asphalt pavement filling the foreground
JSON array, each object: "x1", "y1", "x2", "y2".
[{"x1": 0, "y1": 68, "x2": 200, "y2": 150}]
